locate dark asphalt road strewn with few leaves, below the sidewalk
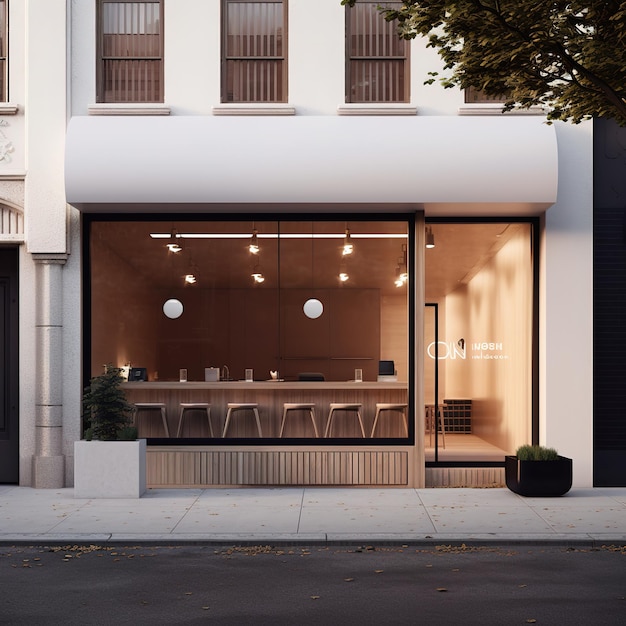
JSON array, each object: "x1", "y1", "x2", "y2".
[{"x1": 0, "y1": 546, "x2": 626, "y2": 626}]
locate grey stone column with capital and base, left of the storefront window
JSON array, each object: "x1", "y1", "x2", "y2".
[{"x1": 32, "y1": 254, "x2": 67, "y2": 489}]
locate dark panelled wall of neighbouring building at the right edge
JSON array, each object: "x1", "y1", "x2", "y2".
[{"x1": 593, "y1": 120, "x2": 626, "y2": 487}]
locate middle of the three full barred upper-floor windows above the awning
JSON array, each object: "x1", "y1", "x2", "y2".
[{"x1": 222, "y1": 0, "x2": 287, "y2": 102}]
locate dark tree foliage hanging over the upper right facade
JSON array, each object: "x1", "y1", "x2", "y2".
[{"x1": 342, "y1": 0, "x2": 626, "y2": 126}]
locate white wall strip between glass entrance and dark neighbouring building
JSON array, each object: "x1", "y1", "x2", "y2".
[{"x1": 540, "y1": 123, "x2": 593, "y2": 487}]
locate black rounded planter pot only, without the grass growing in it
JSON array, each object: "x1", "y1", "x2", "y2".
[{"x1": 504, "y1": 456, "x2": 572, "y2": 497}]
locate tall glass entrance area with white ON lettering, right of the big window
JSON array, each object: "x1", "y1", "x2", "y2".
[{"x1": 424, "y1": 222, "x2": 536, "y2": 463}]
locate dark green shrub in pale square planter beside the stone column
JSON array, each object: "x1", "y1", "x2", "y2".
[{"x1": 74, "y1": 366, "x2": 146, "y2": 498}]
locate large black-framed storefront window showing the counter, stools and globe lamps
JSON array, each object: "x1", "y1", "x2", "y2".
[{"x1": 85, "y1": 216, "x2": 414, "y2": 443}]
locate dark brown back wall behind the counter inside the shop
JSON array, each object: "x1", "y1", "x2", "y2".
[{"x1": 151, "y1": 288, "x2": 380, "y2": 380}]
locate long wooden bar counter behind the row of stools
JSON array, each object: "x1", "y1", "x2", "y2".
[{"x1": 123, "y1": 381, "x2": 411, "y2": 439}]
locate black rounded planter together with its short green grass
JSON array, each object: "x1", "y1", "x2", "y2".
[{"x1": 504, "y1": 445, "x2": 572, "y2": 497}]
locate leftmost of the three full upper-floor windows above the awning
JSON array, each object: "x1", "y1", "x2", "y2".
[{"x1": 97, "y1": 0, "x2": 163, "y2": 102}]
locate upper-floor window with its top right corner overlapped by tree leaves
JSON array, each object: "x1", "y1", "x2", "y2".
[{"x1": 346, "y1": 0, "x2": 409, "y2": 102}]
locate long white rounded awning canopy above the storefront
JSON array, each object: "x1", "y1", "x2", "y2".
[{"x1": 65, "y1": 116, "x2": 558, "y2": 216}]
